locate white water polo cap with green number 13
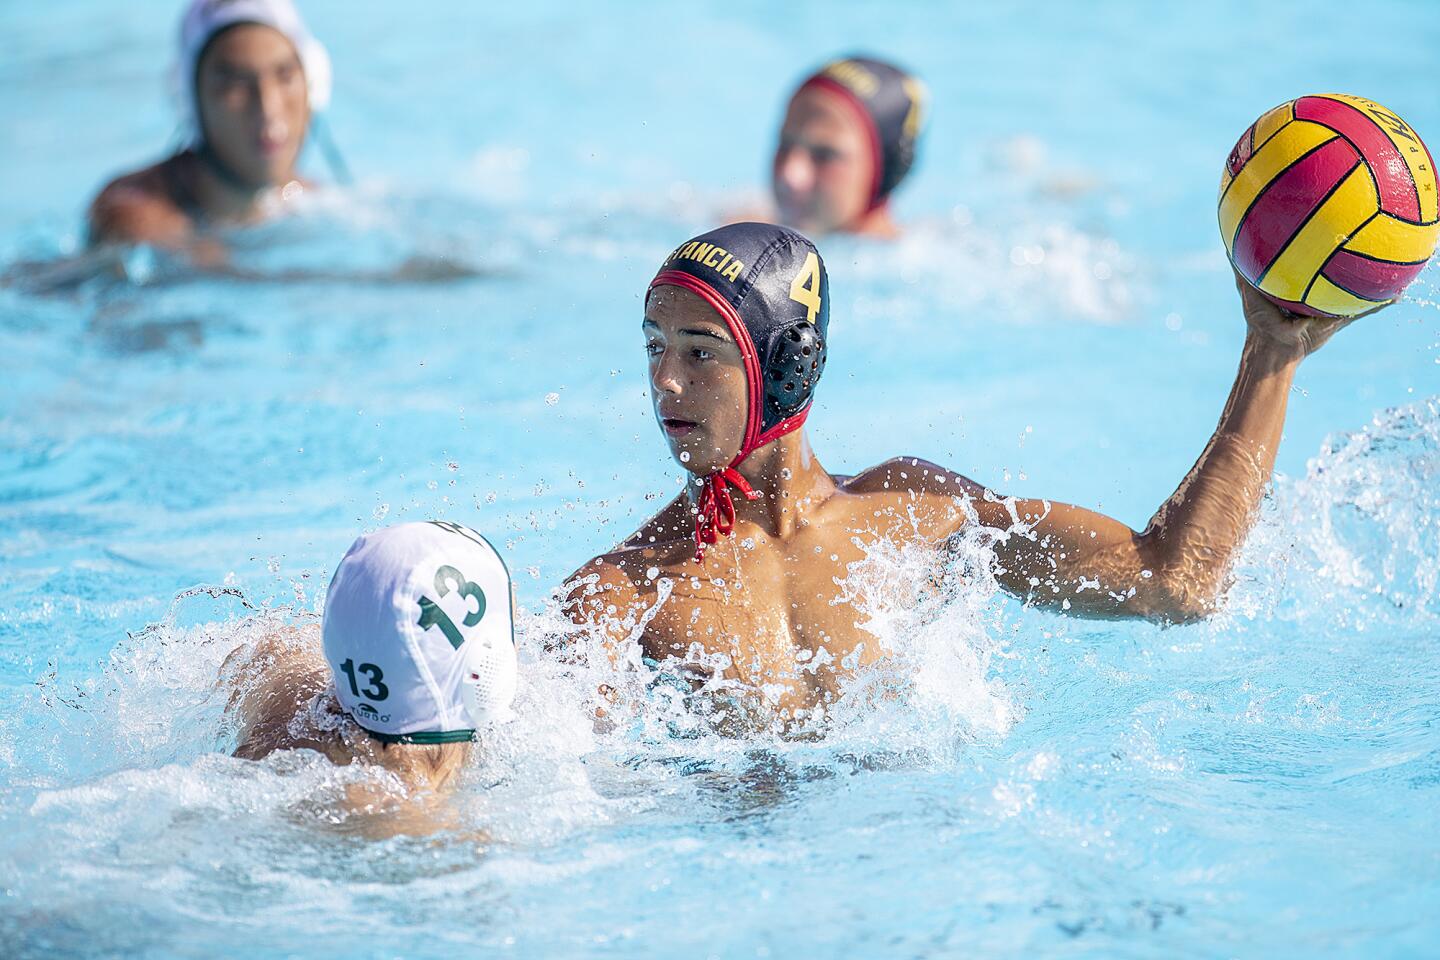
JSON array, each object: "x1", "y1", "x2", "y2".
[{"x1": 323, "y1": 521, "x2": 517, "y2": 744}]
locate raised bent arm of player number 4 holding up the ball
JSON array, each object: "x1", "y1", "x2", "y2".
[{"x1": 975, "y1": 278, "x2": 1349, "y2": 622}]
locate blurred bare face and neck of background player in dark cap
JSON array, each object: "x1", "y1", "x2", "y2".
[{"x1": 772, "y1": 86, "x2": 896, "y2": 236}]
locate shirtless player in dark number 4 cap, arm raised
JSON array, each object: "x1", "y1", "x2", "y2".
[{"x1": 567, "y1": 223, "x2": 1365, "y2": 720}]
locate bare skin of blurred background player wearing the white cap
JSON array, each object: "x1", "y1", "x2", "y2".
[{"x1": 89, "y1": 24, "x2": 310, "y2": 254}]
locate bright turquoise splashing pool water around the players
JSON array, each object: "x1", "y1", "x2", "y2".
[{"x1": 0, "y1": 0, "x2": 1440, "y2": 957}]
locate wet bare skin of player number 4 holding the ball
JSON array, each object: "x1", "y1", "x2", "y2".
[{"x1": 567, "y1": 281, "x2": 1349, "y2": 720}]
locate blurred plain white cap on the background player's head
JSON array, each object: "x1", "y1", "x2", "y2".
[{"x1": 170, "y1": 0, "x2": 330, "y2": 144}]
